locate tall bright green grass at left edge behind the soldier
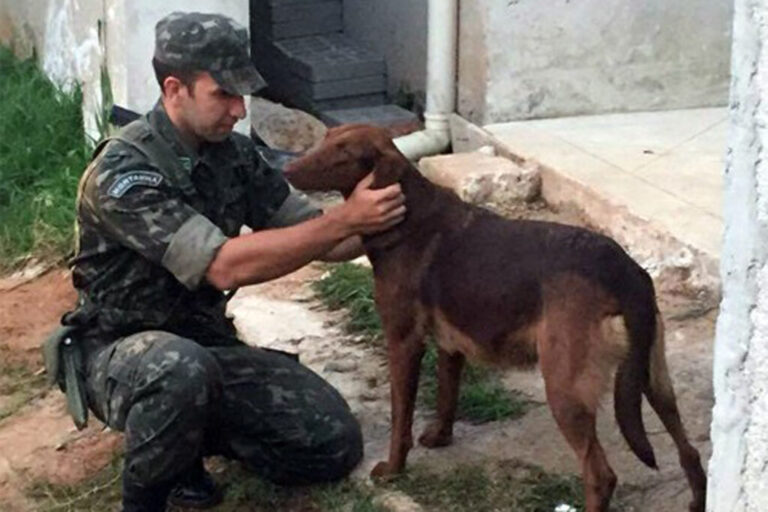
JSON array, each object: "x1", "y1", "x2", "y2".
[{"x1": 0, "y1": 47, "x2": 90, "y2": 271}]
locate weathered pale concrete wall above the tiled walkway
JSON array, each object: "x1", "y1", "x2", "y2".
[{"x1": 458, "y1": 0, "x2": 733, "y2": 124}]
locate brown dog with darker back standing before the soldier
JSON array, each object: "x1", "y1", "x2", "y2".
[{"x1": 286, "y1": 125, "x2": 706, "y2": 512}]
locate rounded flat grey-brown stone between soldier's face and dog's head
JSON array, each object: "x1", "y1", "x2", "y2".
[{"x1": 251, "y1": 98, "x2": 327, "y2": 152}]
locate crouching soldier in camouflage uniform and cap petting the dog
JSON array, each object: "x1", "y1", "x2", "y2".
[{"x1": 63, "y1": 13, "x2": 405, "y2": 512}]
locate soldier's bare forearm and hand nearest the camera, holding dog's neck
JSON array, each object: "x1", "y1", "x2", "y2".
[{"x1": 206, "y1": 175, "x2": 405, "y2": 290}]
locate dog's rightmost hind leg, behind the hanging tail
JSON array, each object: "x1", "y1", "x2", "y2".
[{"x1": 645, "y1": 315, "x2": 707, "y2": 512}]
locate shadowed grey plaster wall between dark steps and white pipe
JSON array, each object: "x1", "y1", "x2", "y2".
[{"x1": 344, "y1": 0, "x2": 427, "y2": 94}]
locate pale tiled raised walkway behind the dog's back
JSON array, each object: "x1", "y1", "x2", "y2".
[{"x1": 483, "y1": 108, "x2": 728, "y2": 260}]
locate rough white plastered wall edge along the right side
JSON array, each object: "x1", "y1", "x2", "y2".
[{"x1": 707, "y1": 0, "x2": 768, "y2": 512}]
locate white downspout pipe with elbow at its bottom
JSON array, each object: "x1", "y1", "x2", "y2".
[{"x1": 394, "y1": 0, "x2": 459, "y2": 160}]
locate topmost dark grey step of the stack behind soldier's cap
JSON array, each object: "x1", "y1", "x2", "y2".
[{"x1": 251, "y1": 0, "x2": 344, "y2": 40}]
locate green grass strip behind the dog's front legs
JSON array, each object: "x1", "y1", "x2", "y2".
[{"x1": 313, "y1": 263, "x2": 528, "y2": 423}]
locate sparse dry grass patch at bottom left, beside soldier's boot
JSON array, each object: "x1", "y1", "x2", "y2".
[{"x1": 26, "y1": 454, "x2": 123, "y2": 512}]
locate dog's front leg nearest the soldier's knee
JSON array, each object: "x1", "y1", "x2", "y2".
[{"x1": 371, "y1": 334, "x2": 424, "y2": 478}]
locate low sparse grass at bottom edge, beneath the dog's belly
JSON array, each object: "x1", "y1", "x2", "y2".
[{"x1": 388, "y1": 461, "x2": 584, "y2": 512}]
